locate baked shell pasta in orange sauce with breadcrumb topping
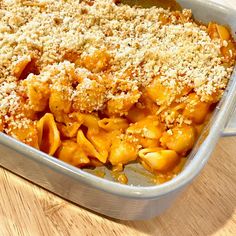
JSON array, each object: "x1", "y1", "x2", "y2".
[{"x1": 0, "y1": 0, "x2": 236, "y2": 183}]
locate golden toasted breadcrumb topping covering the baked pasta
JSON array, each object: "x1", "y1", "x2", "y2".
[{"x1": 0, "y1": 0, "x2": 233, "y2": 133}]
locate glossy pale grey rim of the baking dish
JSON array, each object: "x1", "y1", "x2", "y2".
[{"x1": 0, "y1": 0, "x2": 236, "y2": 199}]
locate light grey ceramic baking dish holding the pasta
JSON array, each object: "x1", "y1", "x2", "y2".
[{"x1": 0, "y1": 0, "x2": 236, "y2": 220}]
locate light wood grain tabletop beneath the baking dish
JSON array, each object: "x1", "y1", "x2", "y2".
[{"x1": 0, "y1": 0, "x2": 236, "y2": 236}]
